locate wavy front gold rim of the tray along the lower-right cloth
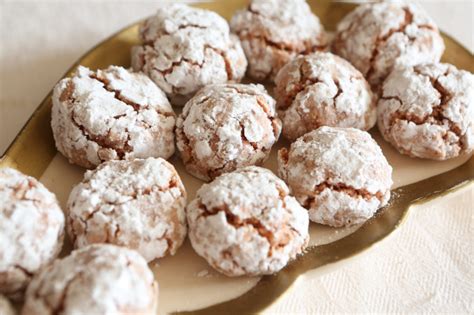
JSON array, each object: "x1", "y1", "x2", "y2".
[{"x1": 179, "y1": 164, "x2": 474, "y2": 314}]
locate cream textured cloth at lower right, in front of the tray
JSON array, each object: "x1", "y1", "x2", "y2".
[{"x1": 267, "y1": 185, "x2": 474, "y2": 314}]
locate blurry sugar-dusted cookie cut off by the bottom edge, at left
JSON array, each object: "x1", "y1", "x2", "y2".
[{"x1": 22, "y1": 244, "x2": 158, "y2": 315}]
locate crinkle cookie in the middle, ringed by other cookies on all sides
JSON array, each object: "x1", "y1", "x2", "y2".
[{"x1": 176, "y1": 84, "x2": 281, "y2": 181}]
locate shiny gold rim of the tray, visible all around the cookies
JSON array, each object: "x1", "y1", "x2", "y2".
[{"x1": 0, "y1": 0, "x2": 474, "y2": 314}]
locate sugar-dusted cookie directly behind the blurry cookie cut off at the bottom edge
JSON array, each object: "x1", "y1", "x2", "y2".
[{"x1": 67, "y1": 158, "x2": 186, "y2": 261}]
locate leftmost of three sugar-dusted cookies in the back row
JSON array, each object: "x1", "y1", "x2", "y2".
[{"x1": 132, "y1": 4, "x2": 247, "y2": 105}]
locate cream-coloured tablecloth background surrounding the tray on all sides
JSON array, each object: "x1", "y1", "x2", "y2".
[{"x1": 0, "y1": 0, "x2": 474, "y2": 313}]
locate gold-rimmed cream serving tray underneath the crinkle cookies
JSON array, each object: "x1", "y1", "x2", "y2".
[{"x1": 0, "y1": 0, "x2": 474, "y2": 314}]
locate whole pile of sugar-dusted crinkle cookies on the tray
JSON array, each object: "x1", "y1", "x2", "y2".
[{"x1": 0, "y1": 0, "x2": 474, "y2": 315}]
